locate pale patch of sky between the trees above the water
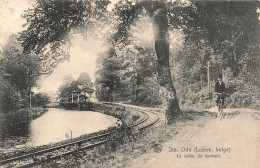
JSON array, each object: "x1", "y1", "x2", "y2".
[{"x1": 37, "y1": 35, "x2": 105, "y2": 92}]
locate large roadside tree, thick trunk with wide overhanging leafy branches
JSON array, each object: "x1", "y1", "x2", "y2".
[{"x1": 20, "y1": 0, "x2": 259, "y2": 121}]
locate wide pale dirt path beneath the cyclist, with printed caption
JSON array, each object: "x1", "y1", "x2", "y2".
[{"x1": 130, "y1": 109, "x2": 260, "y2": 168}]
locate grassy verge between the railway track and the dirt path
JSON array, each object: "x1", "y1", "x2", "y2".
[{"x1": 27, "y1": 107, "x2": 216, "y2": 168}]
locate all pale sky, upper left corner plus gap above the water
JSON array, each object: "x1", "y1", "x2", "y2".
[{"x1": 0, "y1": 0, "x2": 107, "y2": 93}]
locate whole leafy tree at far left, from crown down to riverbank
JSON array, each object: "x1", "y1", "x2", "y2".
[{"x1": 1, "y1": 35, "x2": 41, "y2": 108}]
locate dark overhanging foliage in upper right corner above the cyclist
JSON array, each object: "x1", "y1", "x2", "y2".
[{"x1": 179, "y1": 0, "x2": 260, "y2": 77}]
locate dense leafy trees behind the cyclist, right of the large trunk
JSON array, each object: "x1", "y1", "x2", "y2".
[{"x1": 171, "y1": 1, "x2": 259, "y2": 107}]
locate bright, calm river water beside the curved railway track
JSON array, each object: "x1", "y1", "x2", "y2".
[{"x1": 0, "y1": 108, "x2": 117, "y2": 146}]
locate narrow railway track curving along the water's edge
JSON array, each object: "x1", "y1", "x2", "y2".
[{"x1": 0, "y1": 104, "x2": 159, "y2": 167}]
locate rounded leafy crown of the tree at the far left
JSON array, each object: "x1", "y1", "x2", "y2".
[{"x1": 2, "y1": 36, "x2": 41, "y2": 90}]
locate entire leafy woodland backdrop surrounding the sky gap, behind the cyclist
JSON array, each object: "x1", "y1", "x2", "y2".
[{"x1": 0, "y1": 0, "x2": 260, "y2": 122}]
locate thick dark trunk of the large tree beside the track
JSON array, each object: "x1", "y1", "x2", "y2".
[{"x1": 153, "y1": 8, "x2": 180, "y2": 123}]
